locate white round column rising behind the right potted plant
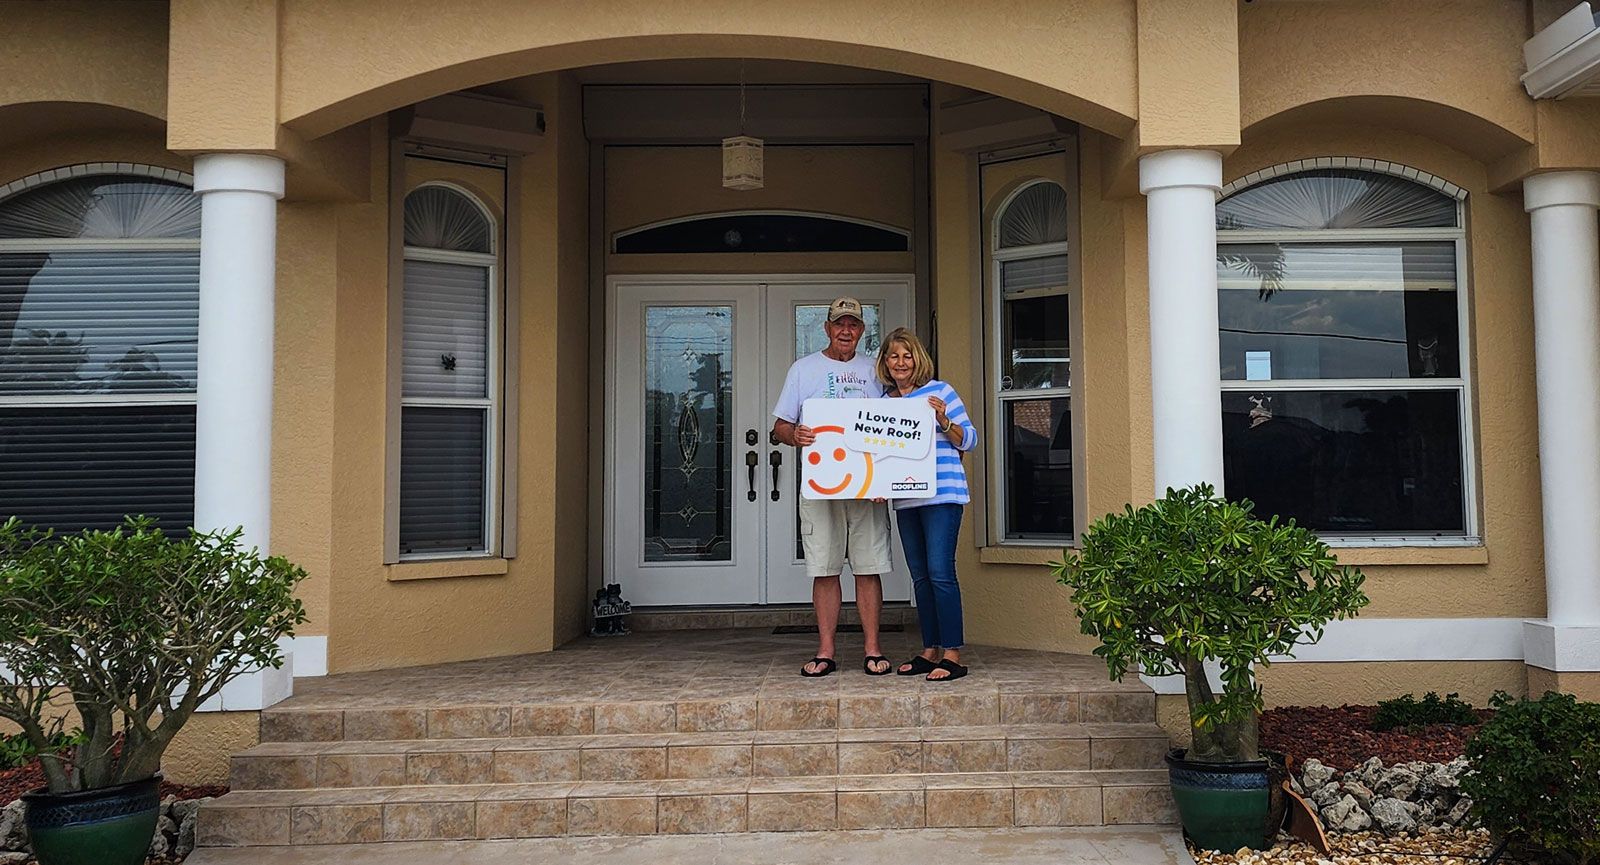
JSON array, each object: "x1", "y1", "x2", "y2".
[{"x1": 1139, "y1": 150, "x2": 1222, "y2": 496}]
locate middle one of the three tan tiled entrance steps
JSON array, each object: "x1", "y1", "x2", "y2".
[{"x1": 232, "y1": 723, "x2": 1168, "y2": 790}]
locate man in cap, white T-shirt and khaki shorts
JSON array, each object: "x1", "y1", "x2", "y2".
[{"x1": 773, "y1": 297, "x2": 891, "y2": 678}]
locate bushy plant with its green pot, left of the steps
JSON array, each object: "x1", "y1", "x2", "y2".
[{"x1": 0, "y1": 516, "x2": 306, "y2": 865}]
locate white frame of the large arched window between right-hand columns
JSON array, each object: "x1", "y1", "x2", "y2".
[{"x1": 1216, "y1": 171, "x2": 1483, "y2": 547}]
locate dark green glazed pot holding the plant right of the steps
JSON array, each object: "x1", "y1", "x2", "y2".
[{"x1": 1166, "y1": 748, "x2": 1288, "y2": 851}]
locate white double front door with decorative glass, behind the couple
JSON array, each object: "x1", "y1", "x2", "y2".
[{"x1": 604, "y1": 275, "x2": 912, "y2": 606}]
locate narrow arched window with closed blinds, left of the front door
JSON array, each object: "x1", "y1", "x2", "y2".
[{"x1": 400, "y1": 184, "x2": 499, "y2": 558}]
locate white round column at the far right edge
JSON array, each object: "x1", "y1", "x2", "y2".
[{"x1": 1523, "y1": 171, "x2": 1600, "y2": 670}]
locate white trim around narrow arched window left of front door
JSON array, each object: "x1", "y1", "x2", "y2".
[{"x1": 384, "y1": 179, "x2": 506, "y2": 563}]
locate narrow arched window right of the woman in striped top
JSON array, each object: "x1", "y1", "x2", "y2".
[{"x1": 989, "y1": 175, "x2": 1074, "y2": 540}]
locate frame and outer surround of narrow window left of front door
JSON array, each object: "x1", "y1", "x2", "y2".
[{"x1": 384, "y1": 165, "x2": 514, "y2": 564}]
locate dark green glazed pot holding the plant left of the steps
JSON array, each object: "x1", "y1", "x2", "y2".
[{"x1": 22, "y1": 774, "x2": 162, "y2": 865}]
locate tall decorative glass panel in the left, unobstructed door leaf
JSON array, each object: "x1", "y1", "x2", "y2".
[{"x1": 640, "y1": 305, "x2": 734, "y2": 561}]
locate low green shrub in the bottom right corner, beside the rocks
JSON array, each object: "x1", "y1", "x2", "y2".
[{"x1": 1461, "y1": 691, "x2": 1600, "y2": 865}]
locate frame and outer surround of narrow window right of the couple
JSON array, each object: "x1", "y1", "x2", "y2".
[{"x1": 979, "y1": 160, "x2": 1085, "y2": 548}]
